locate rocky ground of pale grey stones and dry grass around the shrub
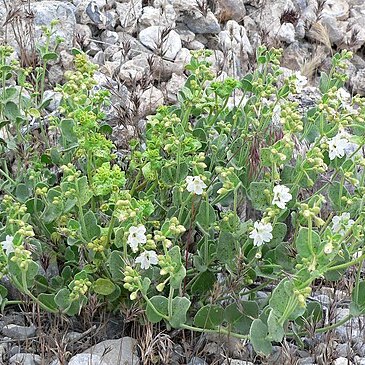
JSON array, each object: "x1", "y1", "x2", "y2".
[{"x1": 0, "y1": 0, "x2": 365, "y2": 365}]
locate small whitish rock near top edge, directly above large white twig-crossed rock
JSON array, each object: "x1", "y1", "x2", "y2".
[{"x1": 139, "y1": 4, "x2": 177, "y2": 29}]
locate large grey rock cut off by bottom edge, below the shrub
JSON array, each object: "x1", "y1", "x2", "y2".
[{"x1": 82, "y1": 337, "x2": 140, "y2": 365}]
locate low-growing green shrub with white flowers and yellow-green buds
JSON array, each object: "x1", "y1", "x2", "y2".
[{"x1": 0, "y1": 47, "x2": 365, "y2": 355}]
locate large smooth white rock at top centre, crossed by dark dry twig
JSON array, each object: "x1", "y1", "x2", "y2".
[{"x1": 138, "y1": 26, "x2": 182, "y2": 60}]
